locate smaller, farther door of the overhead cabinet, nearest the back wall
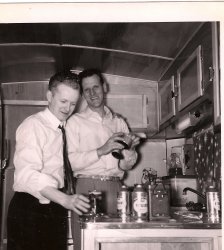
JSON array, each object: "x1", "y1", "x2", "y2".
[{"x1": 158, "y1": 76, "x2": 175, "y2": 125}]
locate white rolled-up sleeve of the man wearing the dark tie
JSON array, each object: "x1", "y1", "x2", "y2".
[{"x1": 14, "y1": 120, "x2": 59, "y2": 203}]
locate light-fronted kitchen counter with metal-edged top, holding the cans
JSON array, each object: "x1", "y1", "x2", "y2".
[{"x1": 80, "y1": 216, "x2": 222, "y2": 250}]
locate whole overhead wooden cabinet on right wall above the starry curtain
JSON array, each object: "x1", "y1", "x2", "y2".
[{"x1": 158, "y1": 22, "x2": 215, "y2": 135}]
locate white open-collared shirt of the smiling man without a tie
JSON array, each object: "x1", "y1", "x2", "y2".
[{"x1": 66, "y1": 107, "x2": 137, "y2": 178}]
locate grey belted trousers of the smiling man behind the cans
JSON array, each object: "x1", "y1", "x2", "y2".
[{"x1": 72, "y1": 178, "x2": 121, "y2": 250}]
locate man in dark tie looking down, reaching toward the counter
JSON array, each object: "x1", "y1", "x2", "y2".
[{"x1": 7, "y1": 71, "x2": 89, "y2": 250}]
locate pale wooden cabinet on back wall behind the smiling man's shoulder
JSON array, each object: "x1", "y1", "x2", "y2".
[{"x1": 104, "y1": 74, "x2": 158, "y2": 135}]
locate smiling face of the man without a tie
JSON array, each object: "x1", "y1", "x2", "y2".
[{"x1": 82, "y1": 75, "x2": 105, "y2": 110}]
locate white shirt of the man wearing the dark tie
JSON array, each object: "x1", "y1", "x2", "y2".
[{"x1": 13, "y1": 108, "x2": 64, "y2": 203}]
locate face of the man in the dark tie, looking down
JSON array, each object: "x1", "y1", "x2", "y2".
[{"x1": 47, "y1": 84, "x2": 79, "y2": 122}]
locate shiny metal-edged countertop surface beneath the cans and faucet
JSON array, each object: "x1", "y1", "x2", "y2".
[{"x1": 80, "y1": 215, "x2": 222, "y2": 229}]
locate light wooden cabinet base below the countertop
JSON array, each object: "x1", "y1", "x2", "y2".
[{"x1": 82, "y1": 228, "x2": 222, "y2": 250}]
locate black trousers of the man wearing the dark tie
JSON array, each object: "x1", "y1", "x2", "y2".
[{"x1": 7, "y1": 192, "x2": 67, "y2": 250}]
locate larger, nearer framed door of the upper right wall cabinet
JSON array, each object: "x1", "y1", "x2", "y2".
[{"x1": 177, "y1": 45, "x2": 203, "y2": 111}]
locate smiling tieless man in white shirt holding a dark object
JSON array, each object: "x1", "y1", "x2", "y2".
[{"x1": 67, "y1": 69, "x2": 139, "y2": 250}]
